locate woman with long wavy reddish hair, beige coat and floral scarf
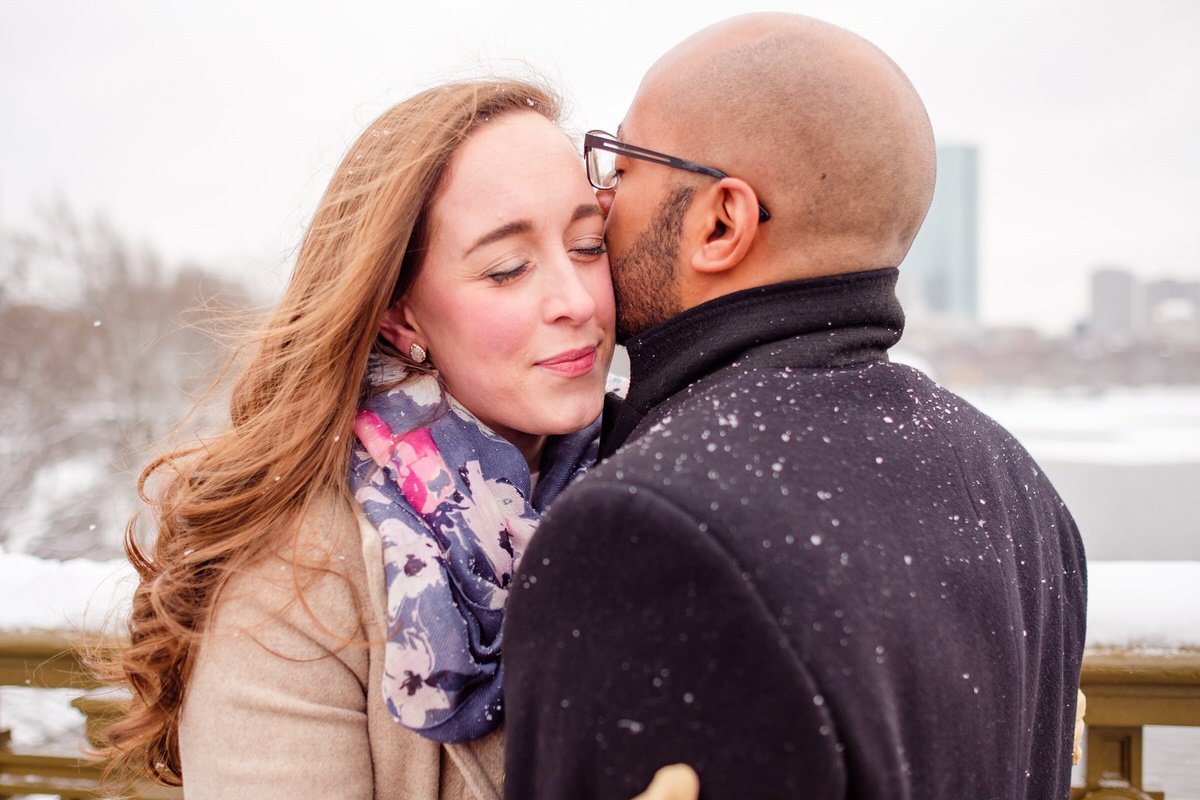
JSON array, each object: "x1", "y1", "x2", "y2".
[{"x1": 110, "y1": 80, "x2": 614, "y2": 800}]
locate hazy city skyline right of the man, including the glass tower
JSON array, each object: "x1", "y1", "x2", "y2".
[{"x1": 896, "y1": 145, "x2": 1200, "y2": 391}]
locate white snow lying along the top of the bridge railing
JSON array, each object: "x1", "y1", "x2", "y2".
[{"x1": 0, "y1": 552, "x2": 1200, "y2": 648}]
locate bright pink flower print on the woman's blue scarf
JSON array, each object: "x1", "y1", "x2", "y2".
[{"x1": 354, "y1": 410, "x2": 454, "y2": 515}]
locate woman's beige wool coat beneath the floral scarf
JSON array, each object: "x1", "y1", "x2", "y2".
[{"x1": 179, "y1": 501, "x2": 504, "y2": 800}]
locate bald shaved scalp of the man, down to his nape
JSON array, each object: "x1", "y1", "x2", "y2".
[{"x1": 626, "y1": 13, "x2": 936, "y2": 277}]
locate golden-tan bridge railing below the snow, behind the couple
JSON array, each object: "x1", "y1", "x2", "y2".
[{"x1": 0, "y1": 632, "x2": 1200, "y2": 800}]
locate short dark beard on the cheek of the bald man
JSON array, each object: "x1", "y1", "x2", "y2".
[{"x1": 610, "y1": 186, "x2": 695, "y2": 342}]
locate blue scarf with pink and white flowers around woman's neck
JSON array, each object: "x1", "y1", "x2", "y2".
[{"x1": 350, "y1": 375, "x2": 600, "y2": 742}]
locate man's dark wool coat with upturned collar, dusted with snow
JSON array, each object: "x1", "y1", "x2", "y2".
[{"x1": 504, "y1": 270, "x2": 1086, "y2": 800}]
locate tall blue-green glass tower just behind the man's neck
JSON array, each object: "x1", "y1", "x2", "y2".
[{"x1": 896, "y1": 145, "x2": 979, "y2": 321}]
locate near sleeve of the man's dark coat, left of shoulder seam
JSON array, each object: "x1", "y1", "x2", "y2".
[{"x1": 504, "y1": 480, "x2": 845, "y2": 800}]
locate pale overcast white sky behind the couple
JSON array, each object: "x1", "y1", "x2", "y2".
[{"x1": 0, "y1": 0, "x2": 1200, "y2": 331}]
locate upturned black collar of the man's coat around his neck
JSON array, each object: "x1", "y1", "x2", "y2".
[{"x1": 601, "y1": 267, "x2": 904, "y2": 456}]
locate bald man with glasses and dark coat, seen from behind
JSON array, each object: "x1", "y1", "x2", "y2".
[{"x1": 505, "y1": 13, "x2": 1085, "y2": 800}]
